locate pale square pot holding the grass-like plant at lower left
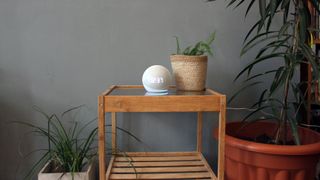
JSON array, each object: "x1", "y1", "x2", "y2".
[{"x1": 38, "y1": 161, "x2": 95, "y2": 180}]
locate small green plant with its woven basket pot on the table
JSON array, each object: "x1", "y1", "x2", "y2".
[{"x1": 170, "y1": 33, "x2": 215, "y2": 91}]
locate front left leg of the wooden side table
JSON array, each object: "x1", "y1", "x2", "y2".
[{"x1": 98, "y1": 95, "x2": 106, "y2": 180}]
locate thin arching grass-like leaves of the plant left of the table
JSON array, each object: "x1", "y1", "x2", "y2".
[{"x1": 14, "y1": 105, "x2": 141, "y2": 179}]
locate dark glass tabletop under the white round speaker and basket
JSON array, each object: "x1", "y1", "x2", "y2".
[{"x1": 109, "y1": 88, "x2": 212, "y2": 96}]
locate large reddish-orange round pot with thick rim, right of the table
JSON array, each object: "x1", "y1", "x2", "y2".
[{"x1": 214, "y1": 122, "x2": 320, "y2": 180}]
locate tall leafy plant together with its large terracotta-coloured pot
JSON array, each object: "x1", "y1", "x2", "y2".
[{"x1": 208, "y1": 0, "x2": 320, "y2": 180}]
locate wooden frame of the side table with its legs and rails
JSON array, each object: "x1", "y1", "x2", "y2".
[{"x1": 98, "y1": 85, "x2": 226, "y2": 180}]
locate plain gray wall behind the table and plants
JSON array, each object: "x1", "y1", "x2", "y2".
[{"x1": 0, "y1": 0, "x2": 262, "y2": 180}]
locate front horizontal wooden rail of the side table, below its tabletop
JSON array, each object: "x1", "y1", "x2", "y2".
[{"x1": 105, "y1": 96, "x2": 220, "y2": 112}]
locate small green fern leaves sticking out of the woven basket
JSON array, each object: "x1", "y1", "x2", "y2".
[{"x1": 175, "y1": 32, "x2": 216, "y2": 56}]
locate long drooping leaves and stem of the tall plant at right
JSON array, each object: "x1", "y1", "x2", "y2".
[{"x1": 209, "y1": 0, "x2": 319, "y2": 145}]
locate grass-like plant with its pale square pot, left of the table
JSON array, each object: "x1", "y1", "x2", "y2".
[{"x1": 14, "y1": 105, "x2": 141, "y2": 180}]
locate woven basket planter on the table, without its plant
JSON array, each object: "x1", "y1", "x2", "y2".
[{"x1": 170, "y1": 55, "x2": 208, "y2": 91}]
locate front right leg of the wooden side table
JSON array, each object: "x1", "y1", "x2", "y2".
[{"x1": 218, "y1": 96, "x2": 226, "y2": 180}]
